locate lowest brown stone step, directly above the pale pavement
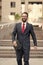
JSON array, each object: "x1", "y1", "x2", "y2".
[{"x1": 0, "y1": 54, "x2": 43, "y2": 58}]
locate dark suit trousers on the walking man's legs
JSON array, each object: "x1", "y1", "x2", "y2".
[{"x1": 16, "y1": 48, "x2": 30, "y2": 65}]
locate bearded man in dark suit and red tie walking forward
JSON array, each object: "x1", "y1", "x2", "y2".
[{"x1": 12, "y1": 12, "x2": 37, "y2": 65}]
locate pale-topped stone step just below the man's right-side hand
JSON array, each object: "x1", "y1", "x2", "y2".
[{"x1": 0, "y1": 46, "x2": 43, "y2": 53}]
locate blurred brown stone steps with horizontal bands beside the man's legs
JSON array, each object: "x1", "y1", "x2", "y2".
[{"x1": 0, "y1": 40, "x2": 43, "y2": 58}]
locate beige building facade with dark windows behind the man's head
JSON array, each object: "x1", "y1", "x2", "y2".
[{"x1": 0, "y1": 0, "x2": 43, "y2": 28}]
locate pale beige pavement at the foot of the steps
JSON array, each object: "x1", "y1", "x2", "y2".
[{"x1": 0, "y1": 58, "x2": 43, "y2": 65}]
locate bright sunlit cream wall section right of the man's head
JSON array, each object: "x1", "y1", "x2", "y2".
[{"x1": 28, "y1": 4, "x2": 42, "y2": 23}]
